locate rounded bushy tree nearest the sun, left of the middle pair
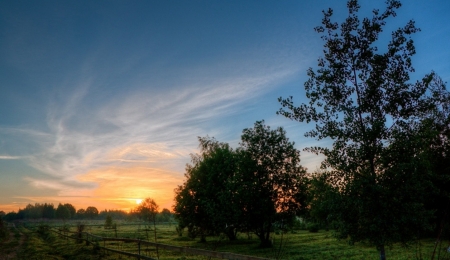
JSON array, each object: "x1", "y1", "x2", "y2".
[{"x1": 174, "y1": 137, "x2": 239, "y2": 241}]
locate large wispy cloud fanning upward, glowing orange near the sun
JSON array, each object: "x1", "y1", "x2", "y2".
[{"x1": 0, "y1": 49, "x2": 304, "y2": 208}]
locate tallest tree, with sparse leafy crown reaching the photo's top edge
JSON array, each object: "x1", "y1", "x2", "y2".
[{"x1": 278, "y1": 0, "x2": 445, "y2": 259}]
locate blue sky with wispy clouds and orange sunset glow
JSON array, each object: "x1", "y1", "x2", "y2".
[{"x1": 0, "y1": 0, "x2": 450, "y2": 212}]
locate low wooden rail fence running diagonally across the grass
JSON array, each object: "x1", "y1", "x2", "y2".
[{"x1": 51, "y1": 229, "x2": 271, "y2": 260}]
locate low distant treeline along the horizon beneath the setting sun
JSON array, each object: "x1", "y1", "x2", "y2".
[{"x1": 0, "y1": 203, "x2": 173, "y2": 222}]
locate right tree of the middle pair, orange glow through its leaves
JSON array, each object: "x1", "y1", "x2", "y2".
[{"x1": 238, "y1": 121, "x2": 306, "y2": 247}]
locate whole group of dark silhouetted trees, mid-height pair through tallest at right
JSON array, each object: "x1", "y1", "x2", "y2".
[{"x1": 174, "y1": 0, "x2": 450, "y2": 259}]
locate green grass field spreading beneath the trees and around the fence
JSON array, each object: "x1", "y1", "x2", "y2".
[{"x1": 0, "y1": 222, "x2": 450, "y2": 260}]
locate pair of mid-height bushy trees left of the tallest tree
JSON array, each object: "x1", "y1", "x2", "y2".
[{"x1": 174, "y1": 121, "x2": 307, "y2": 246}]
